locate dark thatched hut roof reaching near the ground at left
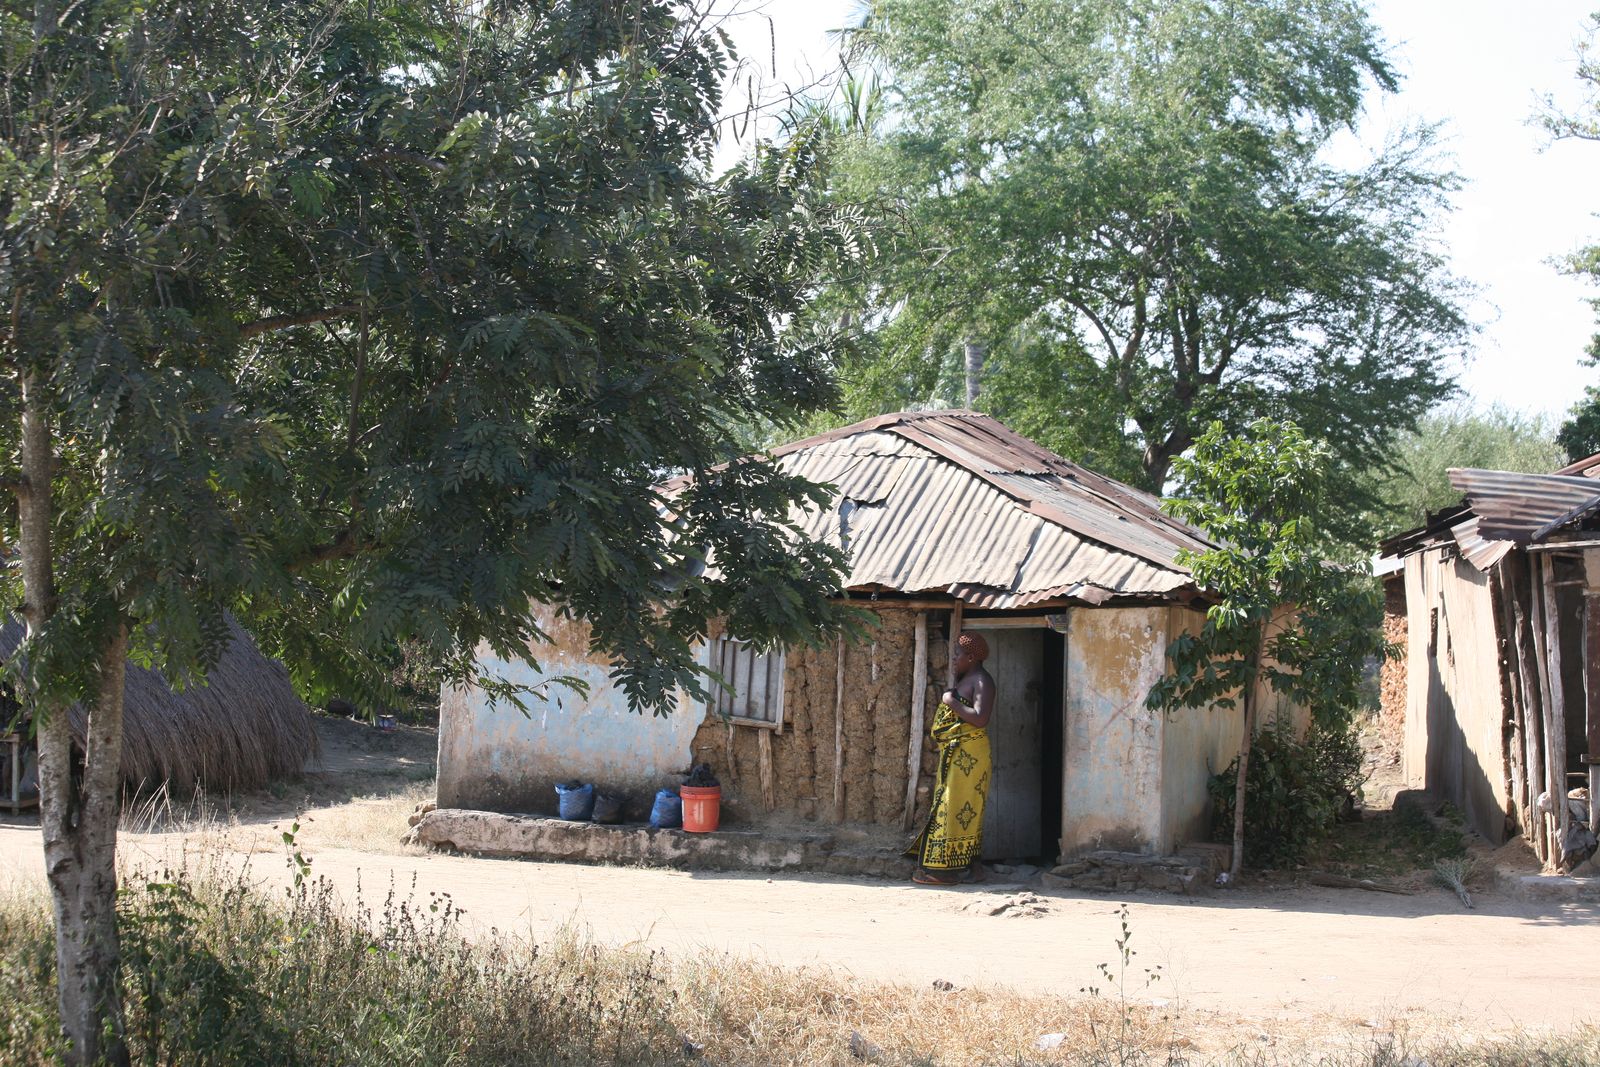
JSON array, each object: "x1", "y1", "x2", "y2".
[{"x1": 0, "y1": 619, "x2": 317, "y2": 793}]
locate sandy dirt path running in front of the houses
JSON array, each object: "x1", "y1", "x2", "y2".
[{"x1": 0, "y1": 825, "x2": 1600, "y2": 1033}]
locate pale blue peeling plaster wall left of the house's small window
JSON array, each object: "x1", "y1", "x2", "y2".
[{"x1": 438, "y1": 608, "x2": 702, "y2": 816}]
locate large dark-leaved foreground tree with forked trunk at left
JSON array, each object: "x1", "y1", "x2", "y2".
[{"x1": 0, "y1": 0, "x2": 858, "y2": 1062}]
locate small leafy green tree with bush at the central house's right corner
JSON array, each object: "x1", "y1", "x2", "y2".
[{"x1": 1147, "y1": 419, "x2": 1395, "y2": 869}]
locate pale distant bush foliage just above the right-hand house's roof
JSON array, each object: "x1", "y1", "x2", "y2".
[{"x1": 1363, "y1": 403, "x2": 1565, "y2": 537}]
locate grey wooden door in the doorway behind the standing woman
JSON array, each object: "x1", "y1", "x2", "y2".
[{"x1": 966, "y1": 624, "x2": 1053, "y2": 859}]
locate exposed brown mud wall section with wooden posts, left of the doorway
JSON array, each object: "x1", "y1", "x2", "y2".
[{"x1": 691, "y1": 608, "x2": 947, "y2": 829}]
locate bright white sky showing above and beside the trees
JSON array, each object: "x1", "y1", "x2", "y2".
[{"x1": 726, "y1": 0, "x2": 1600, "y2": 418}]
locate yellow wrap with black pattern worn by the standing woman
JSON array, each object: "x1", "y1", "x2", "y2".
[{"x1": 914, "y1": 704, "x2": 989, "y2": 870}]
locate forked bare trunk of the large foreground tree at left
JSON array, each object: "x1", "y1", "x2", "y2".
[{"x1": 18, "y1": 373, "x2": 128, "y2": 1064}]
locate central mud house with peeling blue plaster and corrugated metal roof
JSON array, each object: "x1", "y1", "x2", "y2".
[{"x1": 438, "y1": 411, "x2": 1299, "y2": 857}]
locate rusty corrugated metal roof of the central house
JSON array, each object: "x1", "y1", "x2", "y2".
[{"x1": 742, "y1": 410, "x2": 1211, "y2": 608}]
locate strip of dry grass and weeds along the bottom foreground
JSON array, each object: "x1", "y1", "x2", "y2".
[{"x1": 0, "y1": 856, "x2": 1600, "y2": 1067}]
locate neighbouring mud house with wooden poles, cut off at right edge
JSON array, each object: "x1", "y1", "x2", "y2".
[{"x1": 1374, "y1": 456, "x2": 1600, "y2": 867}]
